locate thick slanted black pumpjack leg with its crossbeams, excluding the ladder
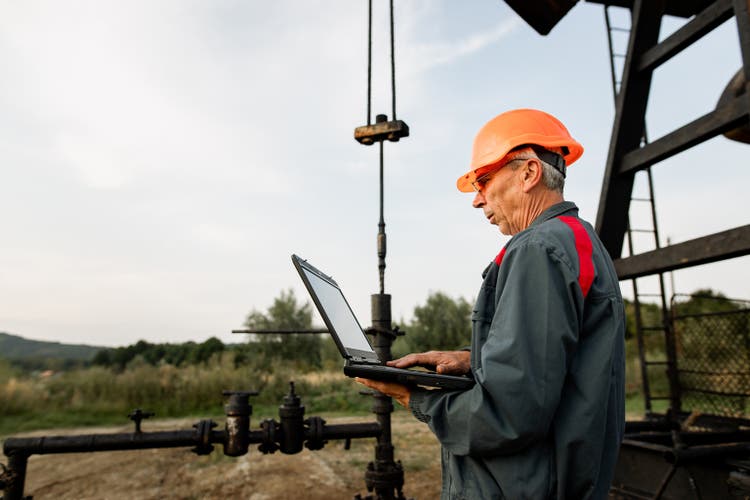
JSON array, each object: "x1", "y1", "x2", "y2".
[{"x1": 596, "y1": 0, "x2": 750, "y2": 274}]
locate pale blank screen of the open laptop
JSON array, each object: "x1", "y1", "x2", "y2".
[{"x1": 302, "y1": 267, "x2": 372, "y2": 352}]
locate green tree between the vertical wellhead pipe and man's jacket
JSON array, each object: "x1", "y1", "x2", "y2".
[{"x1": 397, "y1": 292, "x2": 472, "y2": 352}]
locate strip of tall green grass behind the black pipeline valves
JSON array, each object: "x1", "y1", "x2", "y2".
[{"x1": 0, "y1": 353, "x2": 371, "y2": 435}]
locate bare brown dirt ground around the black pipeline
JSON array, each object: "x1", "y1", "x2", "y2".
[{"x1": 0, "y1": 412, "x2": 440, "y2": 500}]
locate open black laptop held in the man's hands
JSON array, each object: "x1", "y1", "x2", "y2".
[{"x1": 292, "y1": 255, "x2": 474, "y2": 389}]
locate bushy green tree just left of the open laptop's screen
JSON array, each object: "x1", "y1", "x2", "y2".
[{"x1": 244, "y1": 289, "x2": 322, "y2": 367}]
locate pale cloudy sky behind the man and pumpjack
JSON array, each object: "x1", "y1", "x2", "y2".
[{"x1": 0, "y1": 0, "x2": 750, "y2": 345}]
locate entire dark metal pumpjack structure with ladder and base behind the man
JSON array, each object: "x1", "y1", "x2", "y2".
[{"x1": 506, "y1": 0, "x2": 750, "y2": 499}]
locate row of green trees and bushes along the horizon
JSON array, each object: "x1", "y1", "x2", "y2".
[{"x1": 92, "y1": 289, "x2": 739, "y2": 370}]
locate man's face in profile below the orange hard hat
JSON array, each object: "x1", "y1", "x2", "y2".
[{"x1": 472, "y1": 160, "x2": 524, "y2": 235}]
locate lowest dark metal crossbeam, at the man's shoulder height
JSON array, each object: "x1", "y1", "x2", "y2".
[{"x1": 615, "y1": 224, "x2": 750, "y2": 280}]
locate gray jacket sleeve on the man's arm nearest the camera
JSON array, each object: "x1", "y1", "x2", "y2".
[{"x1": 409, "y1": 241, "x2": 583, "y2": 455}]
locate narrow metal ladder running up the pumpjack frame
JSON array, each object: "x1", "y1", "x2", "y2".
[{"x1": 604, "y1": 5, "x2": 680, "y2": 415}]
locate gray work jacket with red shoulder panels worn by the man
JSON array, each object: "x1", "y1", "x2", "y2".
[{"x1": 409, "y1": 202, "x2": 625, "y2": 500}]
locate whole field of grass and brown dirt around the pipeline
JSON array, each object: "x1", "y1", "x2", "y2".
[{"x1": 0, "y1": 352, "x2": 656, "y2": 500}]
